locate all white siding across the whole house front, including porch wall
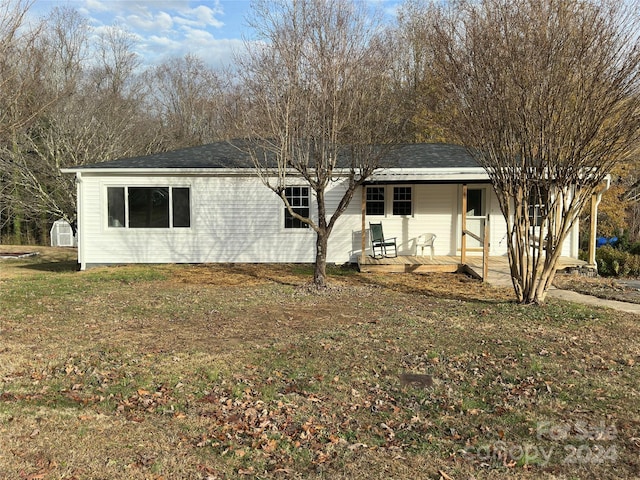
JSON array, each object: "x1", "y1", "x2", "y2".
[{"x1": 71, "y1": 171, "x2": 577, "y2": 268}]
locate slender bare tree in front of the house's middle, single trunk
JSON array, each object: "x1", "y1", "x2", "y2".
[{"x1": 238, "y1": 0, "x2": 410, "y2": 286}]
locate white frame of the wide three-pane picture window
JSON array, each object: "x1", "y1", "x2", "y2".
[{"x1": 104, "y1": 184, "x2": 193, "y2": 231}]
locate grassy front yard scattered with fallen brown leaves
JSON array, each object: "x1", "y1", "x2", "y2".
[{"x1": 0, "y1": 249, "x2": 640, "y2": 479}]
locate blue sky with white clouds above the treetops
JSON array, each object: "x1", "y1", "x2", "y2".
[{"x1": 31, "y1": 0, "x2": 397, "y2": 67}]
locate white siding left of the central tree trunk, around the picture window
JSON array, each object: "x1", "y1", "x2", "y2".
[{"x1": 81, "y1": 174, "x2": 320, "y2": 264}]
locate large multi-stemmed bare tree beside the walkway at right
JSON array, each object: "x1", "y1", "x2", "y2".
[{"x1": 431, "y1": 0, "x2": 640, "y2": 303}]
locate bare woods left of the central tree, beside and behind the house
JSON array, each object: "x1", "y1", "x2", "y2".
[{"x1": 0, "y1": 0, "x2": 225, "y2": 243}]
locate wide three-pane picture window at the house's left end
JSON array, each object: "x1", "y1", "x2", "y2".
[{"x1": 107, "y1": 187, "x2": 191, "y2": 228}]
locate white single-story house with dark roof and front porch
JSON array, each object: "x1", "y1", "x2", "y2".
[{"x1": 63, "y1": 142, "x2": 604, "y2": 270}]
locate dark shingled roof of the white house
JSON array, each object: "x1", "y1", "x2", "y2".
[{"x1": 73, "y1": 142, "x2": 479, "y2": 170}]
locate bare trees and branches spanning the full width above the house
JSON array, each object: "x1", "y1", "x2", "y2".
[{"x1": 0, "y1": 0, "x2": 640, "y2": 294}]
